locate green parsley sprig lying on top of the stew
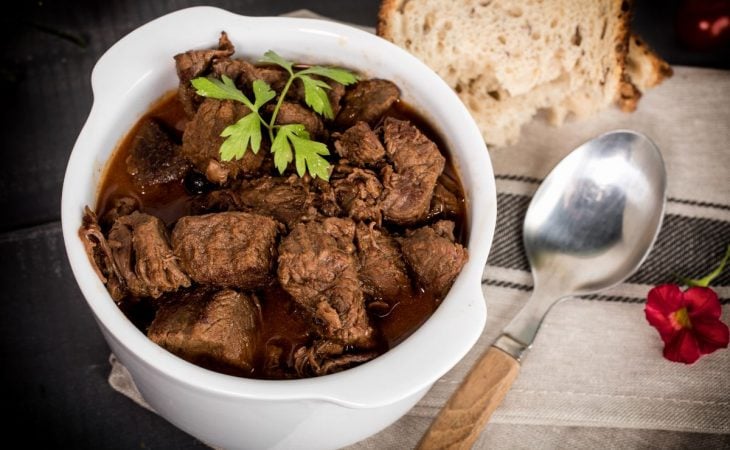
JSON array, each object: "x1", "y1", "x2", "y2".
[{"x1": 191, "y1": 50, "x2": 358, "y2": 180}]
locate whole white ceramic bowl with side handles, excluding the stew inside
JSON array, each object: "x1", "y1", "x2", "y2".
[{"x1": 61, "y1": 7, "x2": 496, "y2": 449}]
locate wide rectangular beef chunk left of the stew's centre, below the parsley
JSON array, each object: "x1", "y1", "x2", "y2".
[{"x1": 172, "y1": 212, "x2": 278, "y2": 290}]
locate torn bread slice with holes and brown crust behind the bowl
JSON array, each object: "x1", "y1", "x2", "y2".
[{"x1": 378, "y1": 0, "x2": 668, "y2": 146}]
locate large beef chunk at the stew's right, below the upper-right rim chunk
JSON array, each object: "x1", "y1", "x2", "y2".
[{"x1": 381, "y1": 117, "x2": 446, "y2": 225}]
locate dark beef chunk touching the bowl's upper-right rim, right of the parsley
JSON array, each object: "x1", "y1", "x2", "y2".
[{"x1": 335, "y1": 79, "x2": 400, "y2": 128}]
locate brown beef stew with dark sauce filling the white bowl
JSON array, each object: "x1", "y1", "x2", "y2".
[{"x1": 80, "y1": 33, "x2": 467, "y2": 379}]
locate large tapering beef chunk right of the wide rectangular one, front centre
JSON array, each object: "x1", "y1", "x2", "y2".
[{"x1": 278, "y1": 217, "x2": 373, "y2": 347}]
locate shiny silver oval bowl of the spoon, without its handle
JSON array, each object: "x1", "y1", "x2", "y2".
[{"x1": 523, "y1": 131, "x2": 666, "y2": 297}]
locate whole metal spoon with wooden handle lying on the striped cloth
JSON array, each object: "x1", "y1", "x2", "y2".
[{"x1": 418, "y1": 130, "x2": 667, "y2": 449}]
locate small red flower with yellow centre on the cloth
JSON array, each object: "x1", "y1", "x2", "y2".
[{"x1": 644, "y1": 284, "x2": 730, "y2": 364}]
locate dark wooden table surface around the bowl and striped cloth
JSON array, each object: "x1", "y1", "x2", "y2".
[{"x1": 0, "y1": 0, "x2": 730, "y2": 448}]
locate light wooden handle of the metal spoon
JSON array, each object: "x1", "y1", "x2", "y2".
[{"x1": 417, "y1": 347, "x2": 520, "y2": 450}]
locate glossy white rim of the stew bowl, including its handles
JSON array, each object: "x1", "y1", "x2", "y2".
[{"x1": 61, "y1": 6, "x2": 496, "y2": 408}]
